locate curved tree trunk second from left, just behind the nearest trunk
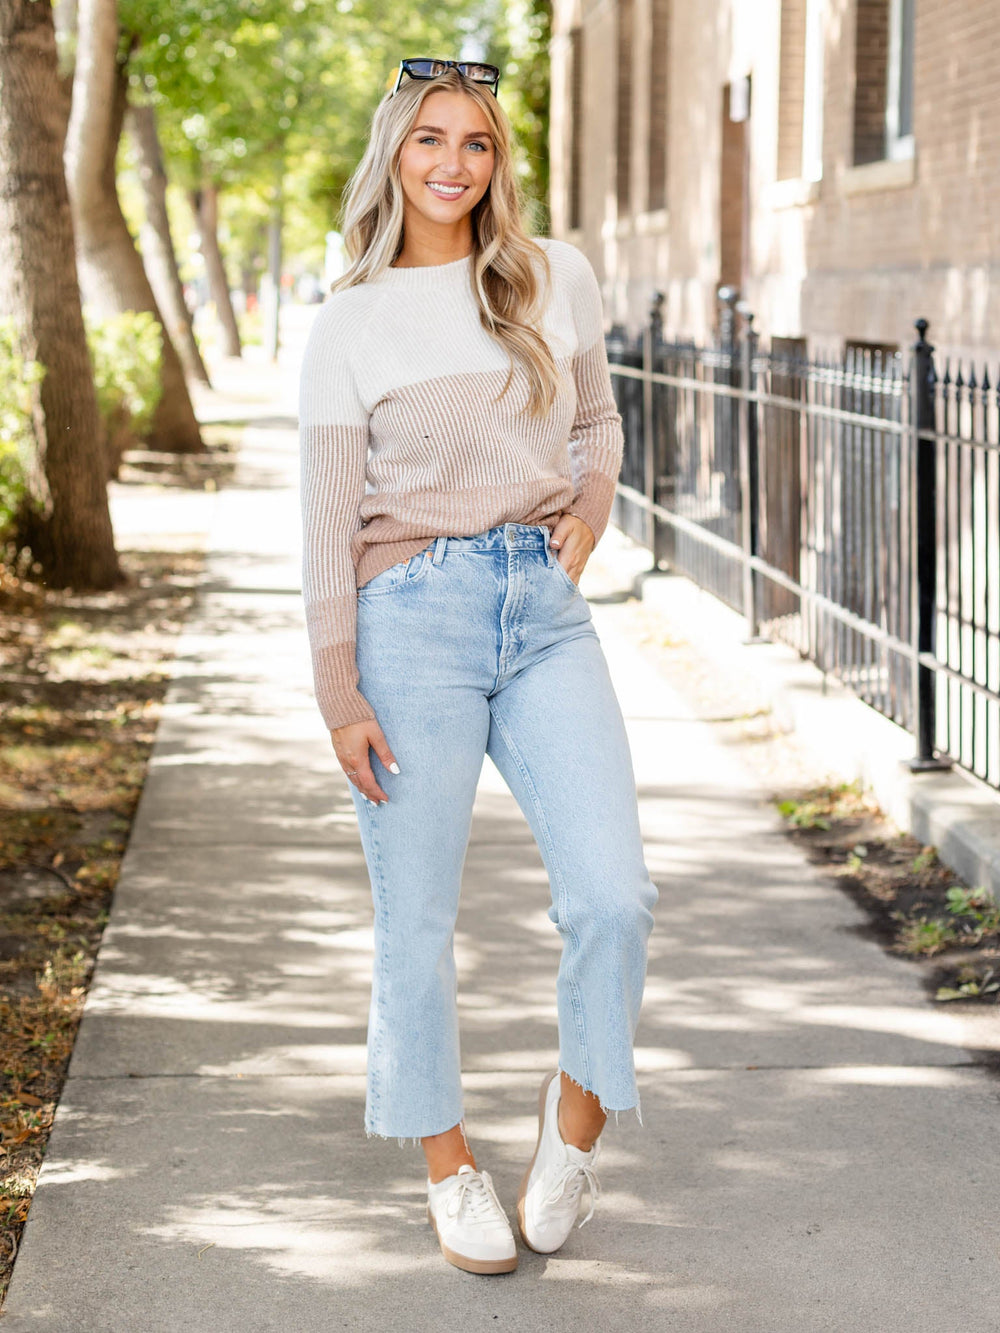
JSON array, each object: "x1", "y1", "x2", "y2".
[{"x1": 65, "y1": 0, "x2": 204, "y2": 452}]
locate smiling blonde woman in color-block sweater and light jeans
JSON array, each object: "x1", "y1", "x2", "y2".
[{"x1": 300, "y1": 60, "x2": 656, "y2": 1273}]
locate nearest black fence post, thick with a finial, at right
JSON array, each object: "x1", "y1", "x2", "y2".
[{"x1": 909, "y1": 319, "x2": 951, "y2": 772}]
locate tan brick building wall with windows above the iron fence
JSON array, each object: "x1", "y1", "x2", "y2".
[{"x1": 551, "y1": 0, "x2": 1000, "y2": 356}]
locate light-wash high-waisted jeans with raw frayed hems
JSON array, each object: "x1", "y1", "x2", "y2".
[{"x1": 351, "y1": 523, "x2": 657, "y2": 1140}]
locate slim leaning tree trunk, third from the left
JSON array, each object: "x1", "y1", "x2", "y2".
[{"x1": 125, "y1": 105, "x2": 209, "y2": 384}]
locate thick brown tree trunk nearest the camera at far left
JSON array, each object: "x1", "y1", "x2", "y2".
[{"x1": 0, "y1": 0, "x2": 121, "y2": 588}]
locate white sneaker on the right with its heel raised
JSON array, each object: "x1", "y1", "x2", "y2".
[{"x1": 517, "y1": 1070, "x2": 600, "y2": 1254}]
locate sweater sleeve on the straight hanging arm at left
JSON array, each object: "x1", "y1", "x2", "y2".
[{"x1": 299, "y1": 292, "x2": 375, "y2": 730}]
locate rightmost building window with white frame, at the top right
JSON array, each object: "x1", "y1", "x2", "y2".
[{"x1": 855, "y1": 0, "x2": 915, "y2": 167}]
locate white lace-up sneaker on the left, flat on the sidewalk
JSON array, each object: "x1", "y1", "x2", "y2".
[{"x1": 427, "y1": 1164, "x2": 517, "y2": 1273}]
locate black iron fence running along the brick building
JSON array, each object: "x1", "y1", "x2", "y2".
[{"x1": 607, "y1": 288, "x2": 1000, "y2": 788}]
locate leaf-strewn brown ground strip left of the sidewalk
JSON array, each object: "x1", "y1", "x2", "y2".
[{"x1": 0, "y1": 538, "x2": 204, "y2": 1300}]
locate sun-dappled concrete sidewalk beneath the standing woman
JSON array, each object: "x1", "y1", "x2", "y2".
[{"x1": 0, "y1": 322, "x2": 1000, "y2": 1333}]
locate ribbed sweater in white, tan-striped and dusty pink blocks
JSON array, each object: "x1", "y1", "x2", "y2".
[{"x1": 299, "y1": 231, "x2": 623, "y2": 730}]
